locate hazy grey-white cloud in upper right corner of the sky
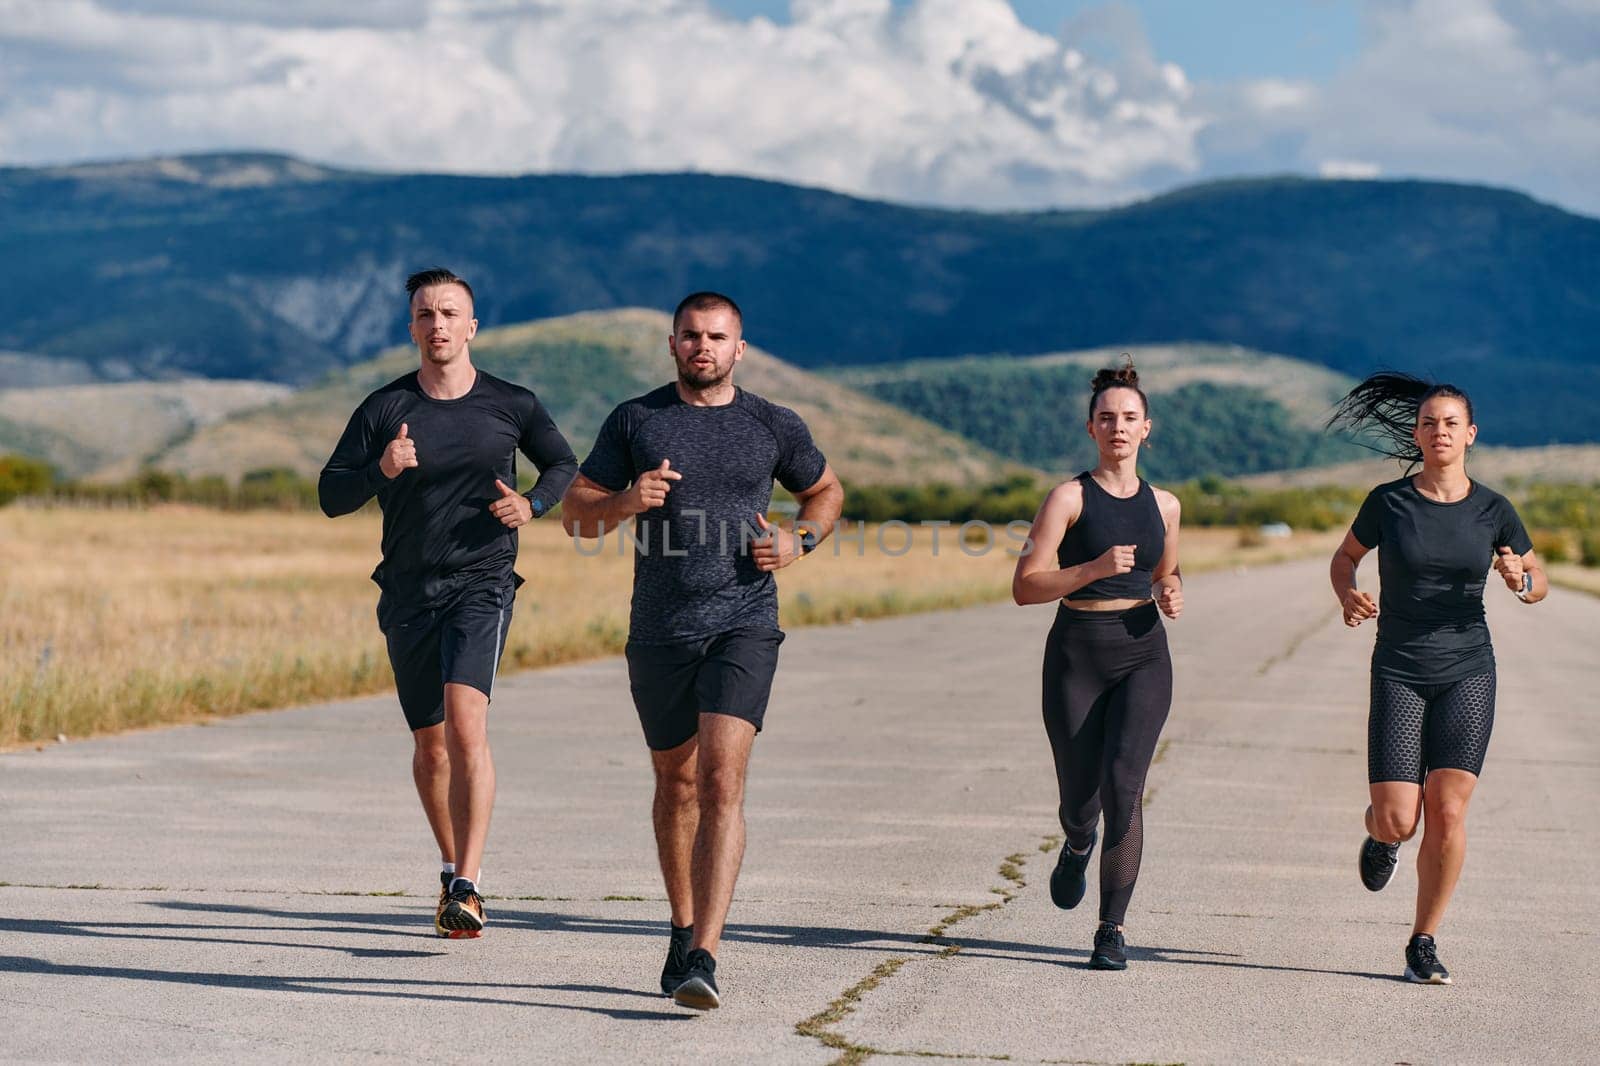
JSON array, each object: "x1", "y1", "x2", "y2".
[{"x1": 1200, "y1": 0, "x2": 1600, "y2": 213}]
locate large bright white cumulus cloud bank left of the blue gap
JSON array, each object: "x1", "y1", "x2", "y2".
[{"x1": 0, "y1": 0, "x2": 1202, "y2": 206}]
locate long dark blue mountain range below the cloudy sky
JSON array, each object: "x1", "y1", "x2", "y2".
[{"x1": 0, "y1": 154, "x2": 1600, "y2": 445}]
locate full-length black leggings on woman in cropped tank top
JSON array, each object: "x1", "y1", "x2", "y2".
[{"x1": 1045, "y1": 603, "x2": 1173, "y2": 925}]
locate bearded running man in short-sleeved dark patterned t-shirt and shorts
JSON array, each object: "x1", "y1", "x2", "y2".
[{"x1": 562, "y1": 293, "x2": 845, "y2": 1008}]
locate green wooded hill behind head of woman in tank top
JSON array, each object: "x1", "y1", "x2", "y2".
[{"x1": 832, "y1": 344, "x2": 1362, "y2": 480}]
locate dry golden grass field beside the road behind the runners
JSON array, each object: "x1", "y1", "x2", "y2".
[{"x1": 0, "y1": 506, "x2": 1338, "y2": 747}]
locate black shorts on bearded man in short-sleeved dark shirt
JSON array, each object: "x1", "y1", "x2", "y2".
[{"x1": 627, "y1": 626, "x2": 784, "y2": 751}]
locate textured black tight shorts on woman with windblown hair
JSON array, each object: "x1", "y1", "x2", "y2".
[{"x1": 1366, "y1": 671, "x2": 1494, "y2": 784}]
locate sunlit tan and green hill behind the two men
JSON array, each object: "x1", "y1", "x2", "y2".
[{"x1": 155, "y1": 309, "x2": 1022, "y2": 483}]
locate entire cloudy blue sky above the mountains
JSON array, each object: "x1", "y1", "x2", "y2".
[{"x1": 0, "y1": 0, "x2": 1600, "y2": 214}]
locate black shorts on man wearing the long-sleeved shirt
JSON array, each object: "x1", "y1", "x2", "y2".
[{"x1": 378, "y1": 584, "x2": 515, "y2": 731}]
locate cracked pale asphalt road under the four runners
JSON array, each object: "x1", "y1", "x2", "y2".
[{"x1": 0, "y1": 562, "x2": 1600, "y2": 1063}]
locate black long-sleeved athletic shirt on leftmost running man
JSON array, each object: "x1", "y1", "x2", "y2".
[{"x1": 317, "y1": 370, "x2": 578, "y2": 605}]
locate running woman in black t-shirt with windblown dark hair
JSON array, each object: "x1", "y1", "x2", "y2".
[{"x1": 1330, "y1": 373, "x2": 1549, "y2": 984}]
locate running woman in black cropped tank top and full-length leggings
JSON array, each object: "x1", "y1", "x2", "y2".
[{"x1": 1011, "y1": 362, "x2": 1184, "y2": 970}]
